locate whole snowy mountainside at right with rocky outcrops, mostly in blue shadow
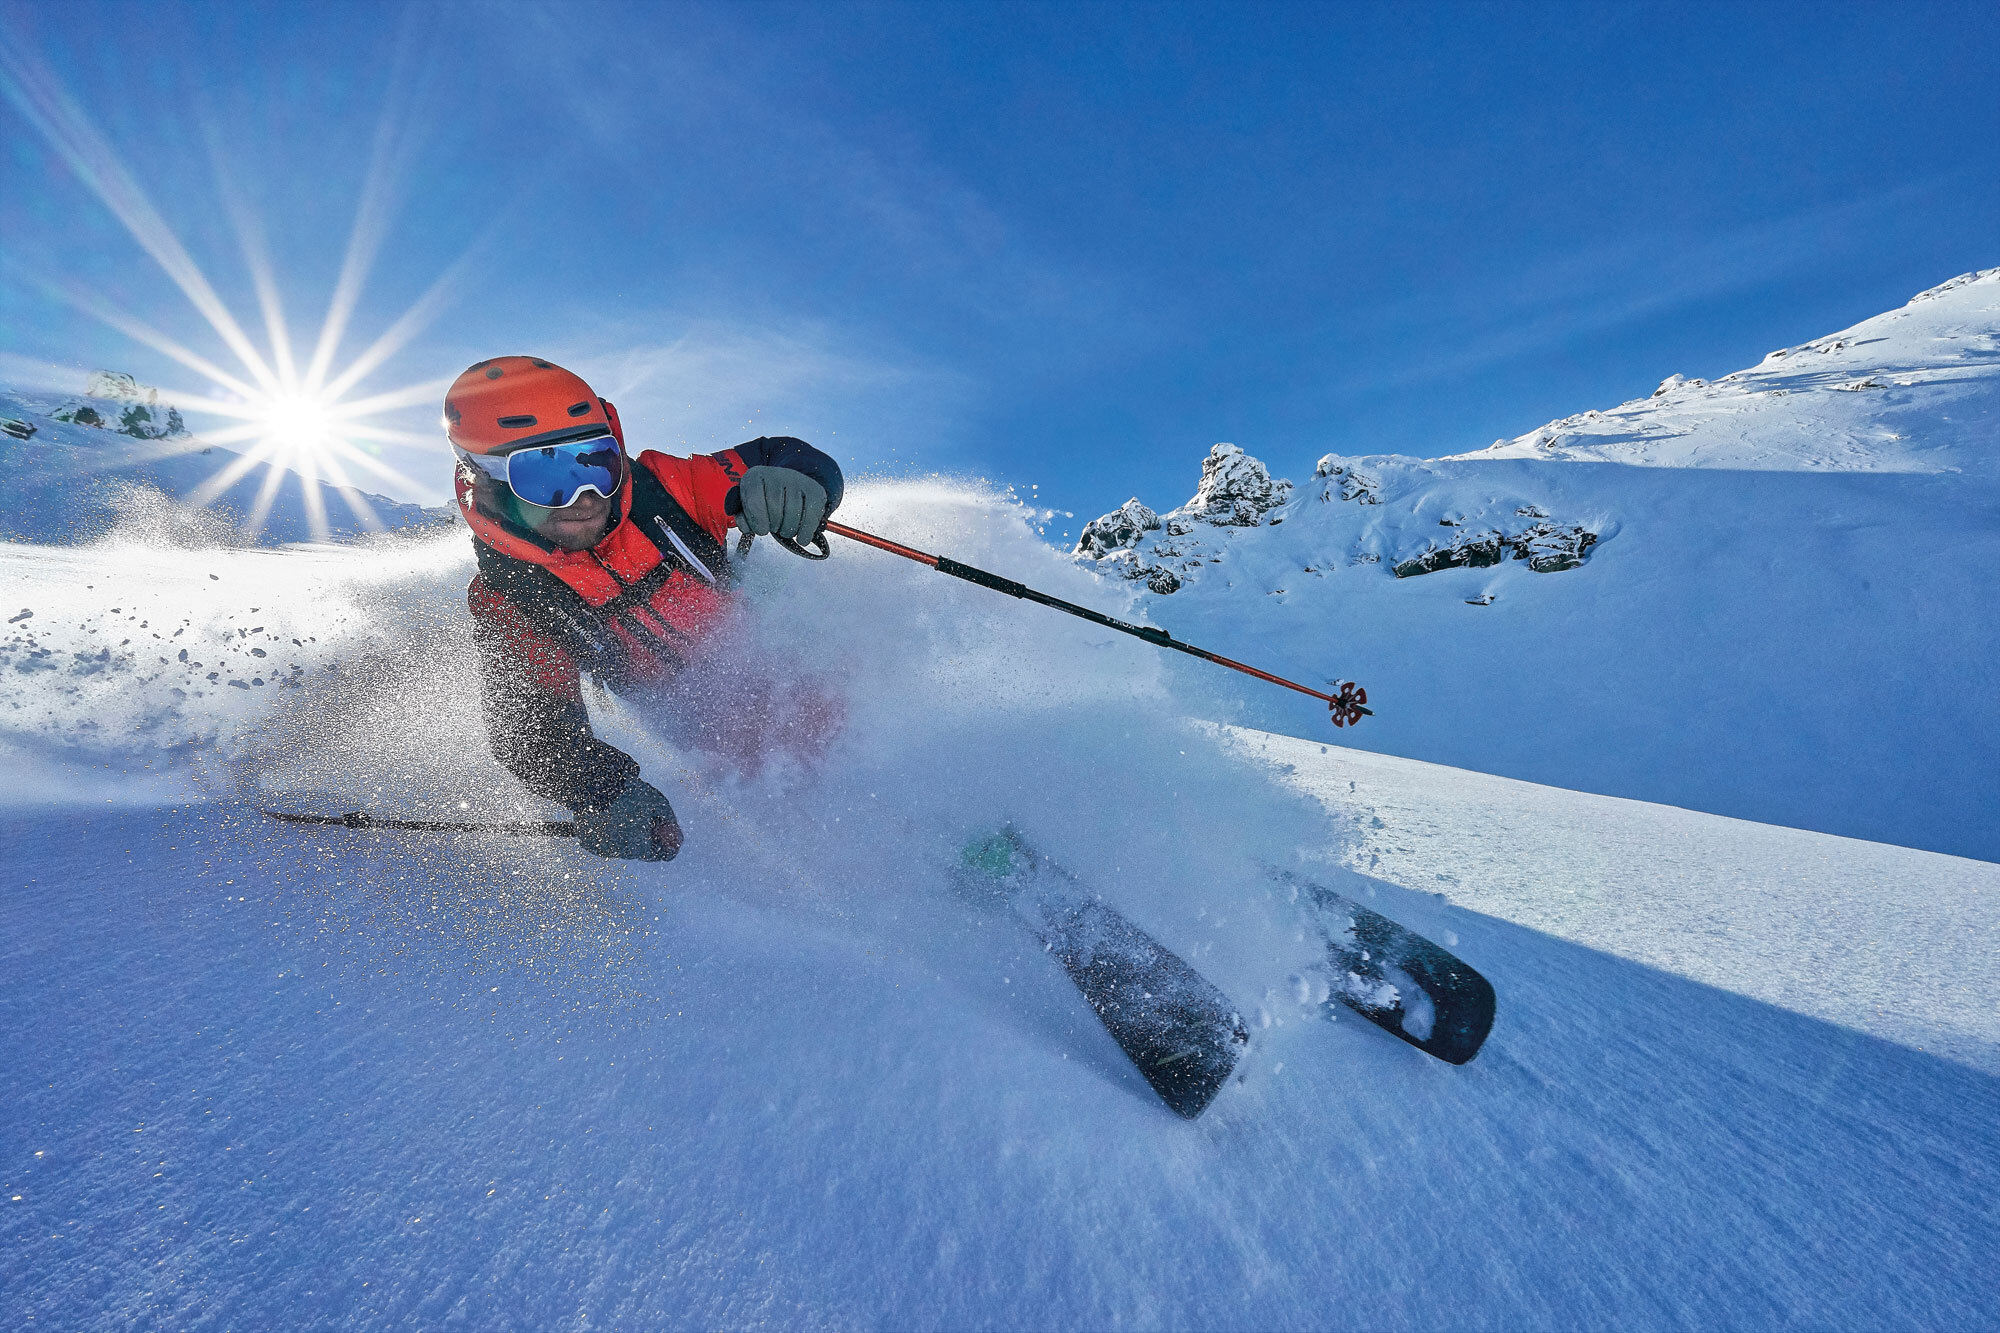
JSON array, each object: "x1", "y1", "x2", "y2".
[{"x1": 1078, "y1": 270, "x2": 2000, "y2": 861}]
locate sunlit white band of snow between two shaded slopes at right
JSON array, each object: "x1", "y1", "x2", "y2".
[{"x1": 1216, "y1": 733, "x2": 2000, "y2": 1075}]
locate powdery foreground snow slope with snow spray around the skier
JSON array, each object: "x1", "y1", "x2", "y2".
[{"x1": 0, "y1": 484, "x2": 2000, "y2": 1329}]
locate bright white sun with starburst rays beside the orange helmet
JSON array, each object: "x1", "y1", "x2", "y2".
[{"x1": 0, "y1": 27, "x2": 466, "y2": 540}]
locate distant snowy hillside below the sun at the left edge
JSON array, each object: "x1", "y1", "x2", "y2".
[{"x1": 0, "y1": 386, "x2": 452, "y2": 546}]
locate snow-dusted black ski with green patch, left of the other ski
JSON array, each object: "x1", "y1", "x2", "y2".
[{"x1": 958, "y1": 829, "x2": 1250, "y2": 1119}]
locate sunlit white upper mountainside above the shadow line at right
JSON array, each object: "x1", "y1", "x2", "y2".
[{"x1": 1456, "y1": 268, "x2": 2000, "y2": 472}]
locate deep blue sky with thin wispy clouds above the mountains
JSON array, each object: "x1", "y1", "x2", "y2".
[{"x1": 0, "y1": 2, "x2": 2000, "y2": 530}]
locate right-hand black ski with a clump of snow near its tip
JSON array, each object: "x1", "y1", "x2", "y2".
[{"x1": 1272, "y1": 869, "x2": 1494, "y2": 1065}]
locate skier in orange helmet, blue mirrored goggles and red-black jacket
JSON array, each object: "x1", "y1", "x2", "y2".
[{"x1": 444, "y1": 356, "x2": 842, "y2": 861}]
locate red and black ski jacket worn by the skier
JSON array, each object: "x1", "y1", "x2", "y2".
[{"x1": 458, "y1": 436, "x2": 842, "y2": 811}]
